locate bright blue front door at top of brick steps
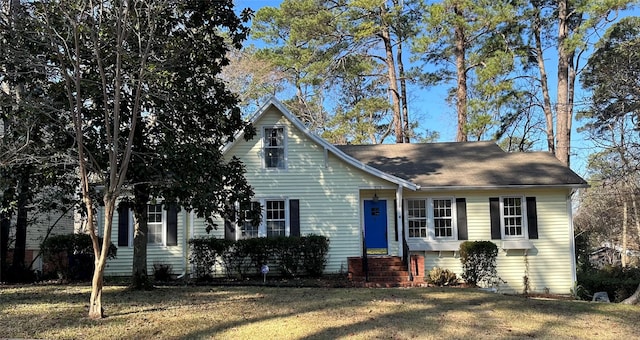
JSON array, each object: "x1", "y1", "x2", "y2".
[{"x1": 364, "y1": 200, "x2": 388, "y2": 255}]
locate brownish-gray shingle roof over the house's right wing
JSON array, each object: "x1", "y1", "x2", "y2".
[{"x1": 336, "y1": 142, "x2": 587, "y2": 188}]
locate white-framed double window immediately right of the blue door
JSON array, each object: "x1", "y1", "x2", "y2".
[{"x1": 407, "y1": 198, "x2": 457, "y2": 240}]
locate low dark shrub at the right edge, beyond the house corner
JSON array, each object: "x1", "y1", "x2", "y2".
[{"x1": 576, "y1": 266, "x2": 640, "y2": 302}]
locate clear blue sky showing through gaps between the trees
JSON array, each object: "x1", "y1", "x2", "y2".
[{"x1": 235, "y1": 0, "x2": 640, "y2": 176}]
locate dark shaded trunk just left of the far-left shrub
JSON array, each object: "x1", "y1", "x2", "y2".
[{"x1": 12, "y1": 166, "x2": 31, "y2": 270}]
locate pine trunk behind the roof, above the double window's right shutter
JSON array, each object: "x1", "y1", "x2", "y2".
[{"x1": 453, "y1": 5, "x2": 468, "y2": 142}]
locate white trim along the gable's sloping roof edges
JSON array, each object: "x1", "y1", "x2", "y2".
[{"x1": 222, "y1": 97, "x2": 420, "y2": 190}]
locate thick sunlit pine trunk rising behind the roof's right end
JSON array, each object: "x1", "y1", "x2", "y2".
[{"x1": 556, "y1": 0, "x2": 572, "y2": 166}]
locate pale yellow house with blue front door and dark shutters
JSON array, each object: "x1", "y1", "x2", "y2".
[{"x1": 102, "y1": 99, "x2": 587, "y2": 294}]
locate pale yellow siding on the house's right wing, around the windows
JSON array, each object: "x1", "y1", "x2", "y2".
[{"x1": 407, "y1": 189, "x2": 573, "y2": 294}]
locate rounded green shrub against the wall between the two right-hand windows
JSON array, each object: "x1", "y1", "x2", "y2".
[{"x1": 460, "y1": 241, "x2": 498, "y2": 286}]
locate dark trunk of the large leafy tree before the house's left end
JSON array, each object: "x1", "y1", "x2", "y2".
[{"x1": 131, "y1": 184, "x2": 152, "y2": 289}]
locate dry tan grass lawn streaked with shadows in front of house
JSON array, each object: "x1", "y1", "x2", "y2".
[{"x1": 0, "y1": 285, "x2": 640, "y2": 340}]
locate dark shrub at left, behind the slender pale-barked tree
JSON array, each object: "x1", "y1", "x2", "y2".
[{"x1": 40, "y1": 234, "x2": 118, "y2": 280}]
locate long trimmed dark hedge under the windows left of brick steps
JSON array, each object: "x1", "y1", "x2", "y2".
[{"x1": 189, "y1": 235, "x2": 329, "y2": 280}]
